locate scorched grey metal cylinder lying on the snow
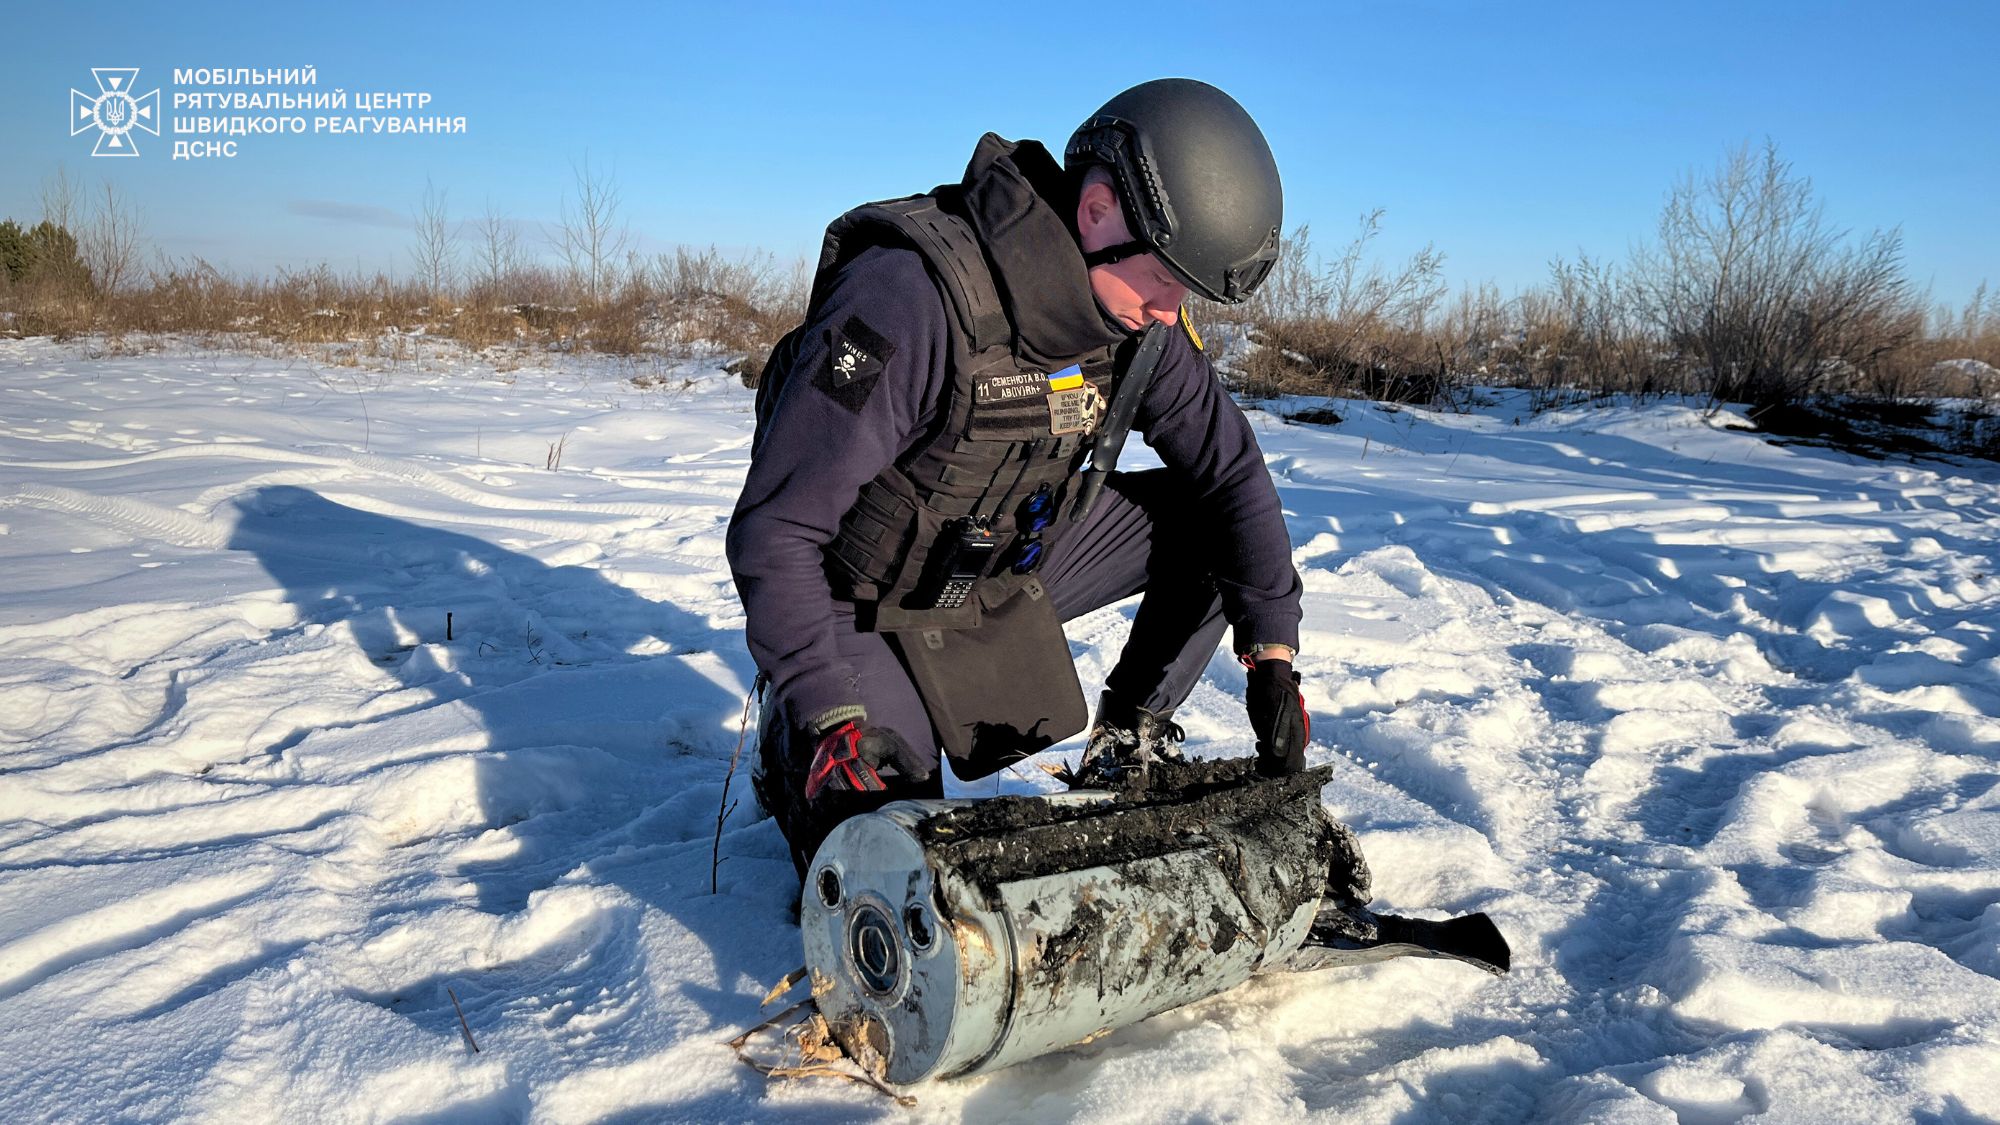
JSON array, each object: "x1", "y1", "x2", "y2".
[{"x1": 800, "y1": 763, "x2": 1332, "y2": 1085}]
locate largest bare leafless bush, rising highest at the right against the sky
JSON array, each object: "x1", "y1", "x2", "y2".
[{"x1": 1632, "y1": 142, "x2": 1922, "y2": 404}]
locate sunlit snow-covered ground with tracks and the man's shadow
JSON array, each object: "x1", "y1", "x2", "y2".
[{"x1": 0, "y1": 340, "x2": 2000, "y2": 1123}]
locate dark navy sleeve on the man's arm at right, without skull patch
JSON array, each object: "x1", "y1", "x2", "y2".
[{"x1": 1134, "y1": 328, "x2": 1304, "y2": 653}]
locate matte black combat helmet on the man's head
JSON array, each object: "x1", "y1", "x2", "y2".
[{"x1": 1062, "y1": 78, "x2": 1284, "y2": 304}]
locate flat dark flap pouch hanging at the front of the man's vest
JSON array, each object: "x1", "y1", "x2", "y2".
[{"x1": 886, "y1": 579, "x2": 1088, "y2": 781}]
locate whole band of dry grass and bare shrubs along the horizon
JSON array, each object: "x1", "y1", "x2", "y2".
[{"x1": 0, "y1": 146, "x2": 2000, "y2": 456}]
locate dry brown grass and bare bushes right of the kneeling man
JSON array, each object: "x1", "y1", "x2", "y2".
[{"x1": 1206, "y1": 164, "x2": 2000, "y2": 456}]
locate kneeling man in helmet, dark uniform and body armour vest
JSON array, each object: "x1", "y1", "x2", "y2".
[{"x1": 728, "y1": 78, "x2": 1308, "y2": 871}]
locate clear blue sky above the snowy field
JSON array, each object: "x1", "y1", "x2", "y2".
[{"x1": 0, "y1": 0, "x2": 2000, "y2": 302}]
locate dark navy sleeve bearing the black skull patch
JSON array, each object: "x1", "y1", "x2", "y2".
[{"x1": 728, "y1": 246, "x2": 948, "y2": 723}]
